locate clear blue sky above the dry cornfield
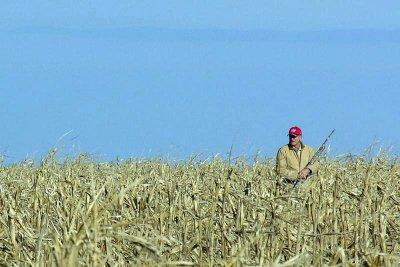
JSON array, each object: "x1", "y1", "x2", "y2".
[{"x1": 0, "y1": 0, "x2": 400, "y2": 162}]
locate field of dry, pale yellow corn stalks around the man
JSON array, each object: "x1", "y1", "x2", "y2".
[{"x1": 0, "y1": 152, "x2": 400, "y2": 266}]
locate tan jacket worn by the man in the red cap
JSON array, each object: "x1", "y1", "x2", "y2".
[{"x1": 276, "y1": 143, "x2": 319, "y2": 181}]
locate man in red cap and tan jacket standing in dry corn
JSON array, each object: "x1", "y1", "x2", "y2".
[{"x1": 276, "y1": 126, "x2": 318, "y2": 183}]
